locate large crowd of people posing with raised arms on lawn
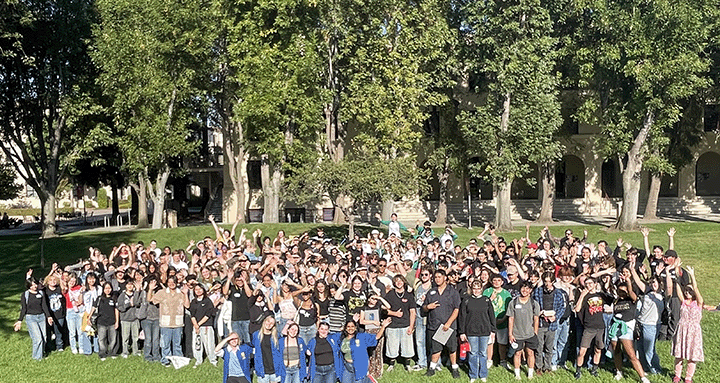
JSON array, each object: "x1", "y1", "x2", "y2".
[{"x1": 15, "y1": 214, "x2": 704, "y2": 383}]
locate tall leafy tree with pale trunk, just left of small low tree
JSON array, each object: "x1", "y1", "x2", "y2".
[{"x1": 226, "y1": 0, "x2": 321, "y2": 222}]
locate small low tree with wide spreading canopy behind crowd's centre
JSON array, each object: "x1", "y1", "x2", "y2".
[{"x1": 285, "y1": 153, "x2": 426, "y2": 238}]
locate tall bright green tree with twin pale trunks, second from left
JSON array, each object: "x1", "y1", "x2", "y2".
[{"x1": 93, "y1": 0, "x2": 217, "y2": 228}]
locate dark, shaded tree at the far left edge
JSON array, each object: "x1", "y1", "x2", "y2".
[{"x1": 0, "y1": 0, "x2": 97, "y2": 237}]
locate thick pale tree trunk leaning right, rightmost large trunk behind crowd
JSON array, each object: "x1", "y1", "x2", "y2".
[{"x1": 614, "y1": 110, "x2": 655, "y2": 231}]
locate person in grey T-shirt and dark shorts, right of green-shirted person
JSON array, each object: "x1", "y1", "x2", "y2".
[{"x1": 507, "y1": 281, "x2": 540, "y2": 380}]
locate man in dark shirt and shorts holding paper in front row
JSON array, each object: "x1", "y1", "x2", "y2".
[{"x1": 422, "y1": 269, "x2": 460, "y2": 379}]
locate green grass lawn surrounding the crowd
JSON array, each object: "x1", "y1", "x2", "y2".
[{"x1": 0, "y1": 223, "x2": 720, "y2": 383}]
